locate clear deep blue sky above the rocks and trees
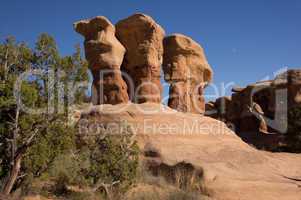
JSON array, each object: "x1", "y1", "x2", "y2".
[{"x1": 0, "y1": 0, "x2": 301, "y2": 99}]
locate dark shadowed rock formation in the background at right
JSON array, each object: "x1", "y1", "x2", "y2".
[{"x1": 206, "y1": 70, "x2": 301, "y2": 133}]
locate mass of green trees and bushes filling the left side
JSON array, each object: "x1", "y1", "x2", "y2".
[{"x1": 0, "y1": 34, "x2": 139, "y2": 197}]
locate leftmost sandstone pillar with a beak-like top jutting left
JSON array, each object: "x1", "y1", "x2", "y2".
[{"x1": 74, "y1": 16, "x2": 129, "y2": 104}]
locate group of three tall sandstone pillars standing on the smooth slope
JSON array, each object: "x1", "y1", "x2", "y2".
[{"x1": 74, "y1": 14, "x2": 212, "y2": 109}]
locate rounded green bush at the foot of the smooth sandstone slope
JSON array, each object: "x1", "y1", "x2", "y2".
[{"x1": 79, "y1": 124, "x2": 139, "y2": 191}]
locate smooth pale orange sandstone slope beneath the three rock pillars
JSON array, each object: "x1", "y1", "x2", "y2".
[{"x1": 74, "y1": 104, "x2": 301, "y2": 200}]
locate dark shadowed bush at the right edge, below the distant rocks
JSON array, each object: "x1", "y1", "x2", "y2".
[{"x1": 285, "y1": 106, "x2": 301, "y2": 153}]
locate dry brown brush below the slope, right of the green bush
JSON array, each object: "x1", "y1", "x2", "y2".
[{"x1": 126, "y1": 160, "x2": 211, "y2": 200}]
